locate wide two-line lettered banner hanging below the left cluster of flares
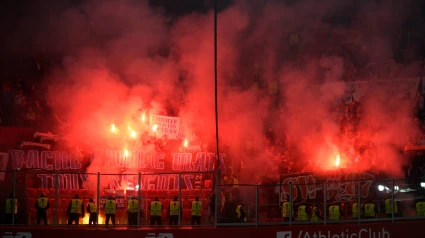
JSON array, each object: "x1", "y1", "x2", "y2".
[{"x1": 5, "y1": 150, "x2": 222, "y2": 191}]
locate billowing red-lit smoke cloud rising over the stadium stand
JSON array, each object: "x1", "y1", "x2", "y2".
[{"x1": 4, "y1": 0, "x2": 419, "y2": 181}]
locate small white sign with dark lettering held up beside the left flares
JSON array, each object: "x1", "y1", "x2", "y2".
[{"x1": 149, "y1": 114, "x2": 180, "y2": 139}]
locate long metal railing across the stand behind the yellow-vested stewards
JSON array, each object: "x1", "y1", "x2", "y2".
[{"x1": 0, "y1": 170, "x2": 425, "y2": 227}]
